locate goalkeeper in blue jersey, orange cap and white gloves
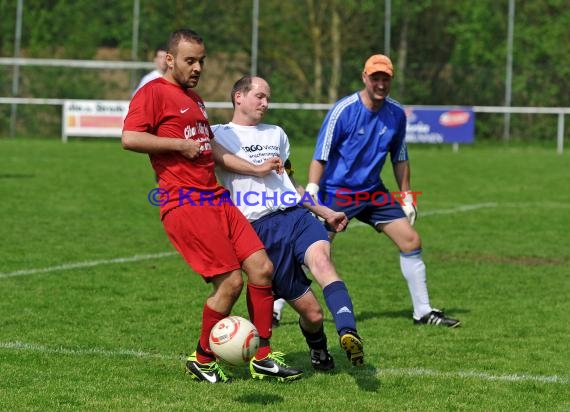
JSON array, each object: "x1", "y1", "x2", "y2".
[{"x1": 306, "y1": 54, "x2": 459, "y2": 327}]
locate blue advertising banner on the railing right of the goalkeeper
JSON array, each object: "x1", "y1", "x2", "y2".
[{"x1": 405, "y1": 106, "x2": 475, "y2": 143}]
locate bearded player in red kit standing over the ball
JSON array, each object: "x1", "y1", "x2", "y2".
[{"x1": 122, "y1": 29, "x2": 302, "y2": 383}]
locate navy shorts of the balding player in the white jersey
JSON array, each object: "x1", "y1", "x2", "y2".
[{"x1": 252, "y1": 207, "x2": 329, "y2": 300}]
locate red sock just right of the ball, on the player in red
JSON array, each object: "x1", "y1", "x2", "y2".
[{"x1": 246, "y1": 283, "x2": 273, "y2": 359}]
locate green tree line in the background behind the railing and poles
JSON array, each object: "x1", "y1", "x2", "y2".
[{"x1": 0, "y1": 0, "x2": 570, "y2": 139}]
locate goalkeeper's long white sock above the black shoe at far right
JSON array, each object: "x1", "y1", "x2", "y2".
[{"x1": 400, "y1": 249, "x2": 432, "y2": 319}]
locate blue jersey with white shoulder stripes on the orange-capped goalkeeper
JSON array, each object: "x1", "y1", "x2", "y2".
[{"x1": 313, "y1": 92, "x2": 408, "y2": 193}]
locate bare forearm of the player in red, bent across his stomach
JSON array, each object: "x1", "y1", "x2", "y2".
[{"x1": 121, "y1": 130, "x2": 200, "y2": 159}]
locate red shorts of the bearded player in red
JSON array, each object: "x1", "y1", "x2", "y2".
[{"x1": 162, "y1": 202, "x2": 263, "y2": 278}]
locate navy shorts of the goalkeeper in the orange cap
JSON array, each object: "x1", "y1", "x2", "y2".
[{"x1": 321, "y1": 188, "x2": 406, "y2": 232}]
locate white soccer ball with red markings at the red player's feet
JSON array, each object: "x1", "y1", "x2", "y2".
[{"x1": 210, "y1": 316, "x2": 259, "y2": 366}]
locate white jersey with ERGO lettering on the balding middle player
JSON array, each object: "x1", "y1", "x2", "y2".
[{"x1": 212, "y1": 122, "x2": 301, "y2": 222}]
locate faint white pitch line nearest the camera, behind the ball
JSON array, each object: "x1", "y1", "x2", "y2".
[{"x1": 0, "y1": 341, "x2": 568, "y2": 385}]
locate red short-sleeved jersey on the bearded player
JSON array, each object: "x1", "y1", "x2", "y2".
[{"x1": 123, "y1": 78, "x2": 226, "y2": 217}]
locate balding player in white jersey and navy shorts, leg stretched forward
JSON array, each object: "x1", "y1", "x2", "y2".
[{"x1": 212, "y1": 76, "x2": 364, "y2": 370}]
